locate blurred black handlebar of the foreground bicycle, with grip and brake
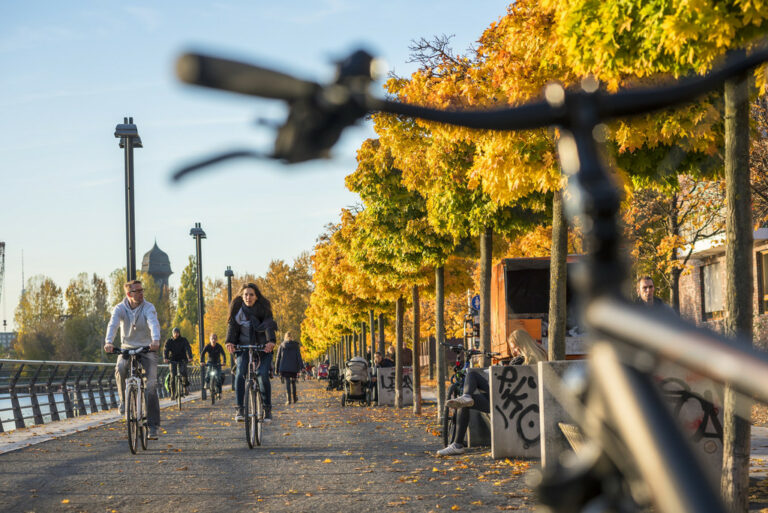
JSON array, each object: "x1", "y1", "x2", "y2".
[{"x1": 176, "y1": 47, "x2": 768, "y2": 169}]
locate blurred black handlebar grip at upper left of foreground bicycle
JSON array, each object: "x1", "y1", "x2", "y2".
[{"x1": 176, "y1": 53, "x2": 319, "y2": 101}]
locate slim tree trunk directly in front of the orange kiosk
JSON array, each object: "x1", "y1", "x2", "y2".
[{"x1": 547, "y1": 189, "x2": 568, "y2": 361}]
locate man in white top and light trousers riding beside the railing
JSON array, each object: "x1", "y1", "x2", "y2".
[{"x1": 104, "y1": 280, "x2": 160, "y2": 440}]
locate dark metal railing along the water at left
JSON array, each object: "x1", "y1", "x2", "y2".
[{"x1": 0, "y1": 359, "x2": 228, "y2": 433}]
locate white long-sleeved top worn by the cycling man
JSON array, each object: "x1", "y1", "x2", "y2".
[{"x1": 104, "y1": 298, "x2": 160, "y2": 349}]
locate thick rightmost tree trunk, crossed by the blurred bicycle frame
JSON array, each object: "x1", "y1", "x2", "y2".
[{"x1": 721, "y1": 69, "x2": 753, "y2": 513}]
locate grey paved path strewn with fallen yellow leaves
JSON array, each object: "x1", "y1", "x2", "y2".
[{"x1": 0, "y1": 380, "x2": 533, "y2": 513}]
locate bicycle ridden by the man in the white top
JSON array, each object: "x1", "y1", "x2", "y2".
[{"x1": 112, "y1": 347, "x2": 149, "y2": 454}]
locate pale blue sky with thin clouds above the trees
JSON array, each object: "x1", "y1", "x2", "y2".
[{"x1": 0, "y1": 0, "x2": 508, "y2": 329}]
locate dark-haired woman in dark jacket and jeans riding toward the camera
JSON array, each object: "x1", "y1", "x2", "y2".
[{"x1": 226, "y1": 283, "x2": 277, "y2": 421}]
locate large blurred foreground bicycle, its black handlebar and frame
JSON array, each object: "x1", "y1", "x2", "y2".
[{"x1": 176, "y1": 44, "x2": 768, "y2": 513}]
